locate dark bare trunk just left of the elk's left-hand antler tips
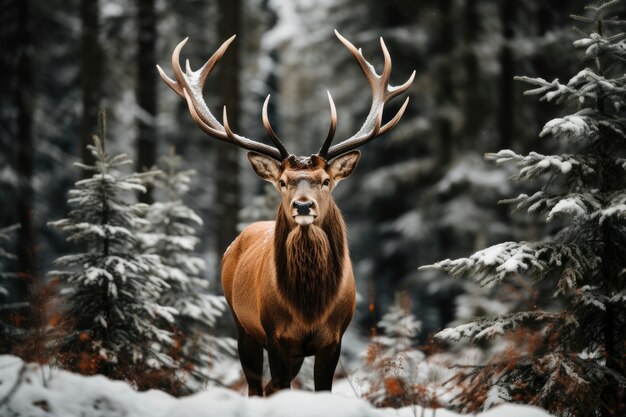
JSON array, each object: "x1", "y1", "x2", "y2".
[{"x1": 137, "y1": 0, "x2": 157, "y2": 203}]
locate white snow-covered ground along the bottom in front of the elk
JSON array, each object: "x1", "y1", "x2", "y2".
[{"x1": 0, "y1": 356, "x2": 549, "y2": 417}]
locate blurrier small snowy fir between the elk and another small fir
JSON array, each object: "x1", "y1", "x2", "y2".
[{"x1": 140, "y1": 148, "x2": 236, "y2": 395}]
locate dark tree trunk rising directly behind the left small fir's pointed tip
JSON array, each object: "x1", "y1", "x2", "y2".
[{"x1": 79, "y1": 0, "x2": 103, "y2": 177}]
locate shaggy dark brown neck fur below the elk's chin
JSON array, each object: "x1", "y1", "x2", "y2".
[{"x1": 274, "y1": 203, "x2": 346, "y2": 322}]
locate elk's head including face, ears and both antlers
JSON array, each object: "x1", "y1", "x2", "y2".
[{"x1": 157, "y1": 31, "x2": 415, "y2": 226}]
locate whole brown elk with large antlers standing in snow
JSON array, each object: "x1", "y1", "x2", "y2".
[{"x1": 157, "y1": 31, "x2": 415, "y2": 395}]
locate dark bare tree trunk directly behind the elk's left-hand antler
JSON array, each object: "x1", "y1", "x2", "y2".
[{"x1": 215, "y1": 0, "x2": 241, "y2": 291}]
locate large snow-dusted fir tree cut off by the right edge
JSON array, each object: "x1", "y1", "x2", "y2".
[{"x1": 426, "y1": 0, "x2": 626, "y2": 416}]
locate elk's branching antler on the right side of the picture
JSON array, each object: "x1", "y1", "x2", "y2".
[{"x1": 318, "y1": 30, "x2": 415, "y2": 161}]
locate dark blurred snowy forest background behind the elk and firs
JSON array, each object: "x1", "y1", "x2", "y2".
[{"x1": 0, "y1": 0, "x2": 586, "y2": 340}]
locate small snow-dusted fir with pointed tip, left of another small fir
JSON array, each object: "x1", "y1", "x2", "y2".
[{"x1": 49, "y1": 135, "x2": 175, "y2": 385}]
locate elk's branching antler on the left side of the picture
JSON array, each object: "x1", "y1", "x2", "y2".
[{"x1": 157, "y1": 36, "x2": 289, "y2": 161}]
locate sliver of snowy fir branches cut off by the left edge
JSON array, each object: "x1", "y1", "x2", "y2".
[{"x1": 0, "y1": 224, "x2": 22, "y2": 354}]
